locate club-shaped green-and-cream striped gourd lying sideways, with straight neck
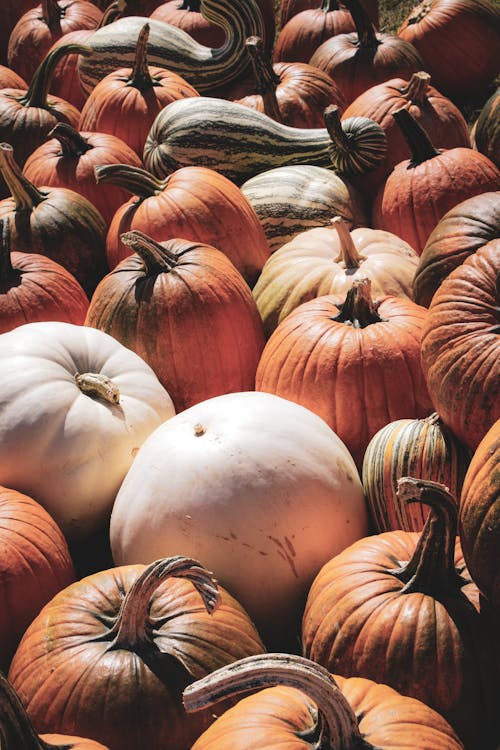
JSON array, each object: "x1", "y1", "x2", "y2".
[{"x1": 144, "y1": 96, "x2": 387, "y2": 185}]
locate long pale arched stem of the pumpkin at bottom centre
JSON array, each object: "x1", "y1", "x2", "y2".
[{"x1": 182, "y1": 654, "x2": 372, "y2": 750}]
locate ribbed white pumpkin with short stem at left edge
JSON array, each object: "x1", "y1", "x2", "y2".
[{"x1": 0, "y1": 322, "x2": 175, "y2": 539}]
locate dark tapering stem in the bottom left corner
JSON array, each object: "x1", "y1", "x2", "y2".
[{"x1": 0, "y1": 672, "x2": 69, "y2": 750}]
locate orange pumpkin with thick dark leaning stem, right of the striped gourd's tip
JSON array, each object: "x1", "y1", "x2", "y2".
[{"x1": 372, "y1": 107, "x2": 500, "y2": 255}]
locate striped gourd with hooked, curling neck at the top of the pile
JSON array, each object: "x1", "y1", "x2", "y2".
[{"x1": 79, "y1": 0, "x2": 265, "y2": 94}]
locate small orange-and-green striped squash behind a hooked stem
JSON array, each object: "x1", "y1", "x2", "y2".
[{"x1": 362, "y1": 413, "x2": 471, "y2": 532}]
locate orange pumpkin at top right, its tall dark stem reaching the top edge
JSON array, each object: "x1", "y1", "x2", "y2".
[{"x1": 309, "y1": 0, "x2": 425, "y2": 104}]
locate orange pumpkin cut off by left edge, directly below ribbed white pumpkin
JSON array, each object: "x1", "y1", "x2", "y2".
[{"x1": 0, "y1": 487, "x2": 75, "y2": 671}]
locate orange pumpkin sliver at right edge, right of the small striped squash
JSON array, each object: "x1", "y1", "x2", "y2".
[{"x1": 459, "y1": 421, "x2": 500, "y2": 616}]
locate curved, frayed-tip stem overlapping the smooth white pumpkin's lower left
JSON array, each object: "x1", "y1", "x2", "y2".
[{"x1": 108, "y1": 555, "x2": 220, "y2": 651}]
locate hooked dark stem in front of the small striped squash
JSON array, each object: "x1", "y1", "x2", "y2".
[{"x1": 390, "y1": 477, "x2": 466, "y2": 598}]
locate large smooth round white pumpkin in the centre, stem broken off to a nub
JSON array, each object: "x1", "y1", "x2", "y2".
[{"x1": 110, "y1": 391, "x2": 368, "y2": 647}]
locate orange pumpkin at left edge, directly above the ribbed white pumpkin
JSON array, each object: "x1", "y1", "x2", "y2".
[{"x1": 0, "y1": 219, "x2": 89, "y2": 333}]
